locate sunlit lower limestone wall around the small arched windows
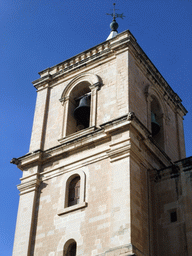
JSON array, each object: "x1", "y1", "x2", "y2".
[{"x1": 31, "y1": 158, "x2": 130, "y2": 256}]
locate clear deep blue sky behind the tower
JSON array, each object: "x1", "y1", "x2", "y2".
[{"x1": 0, "y1": 0, "x2": 192, "y2": 256}]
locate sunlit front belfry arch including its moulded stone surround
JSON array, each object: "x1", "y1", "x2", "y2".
[{"x1": 59, "y1": 73, "x2": 101, "y2": 142}]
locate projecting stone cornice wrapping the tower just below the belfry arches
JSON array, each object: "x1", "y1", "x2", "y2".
[{"x1": 12, "y1": 112, "x2": 171, "y2": 171}]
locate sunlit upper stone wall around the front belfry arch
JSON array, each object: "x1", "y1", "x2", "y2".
[{"x1": 30, "y1": 52, "x2": 128, "y2": 151}]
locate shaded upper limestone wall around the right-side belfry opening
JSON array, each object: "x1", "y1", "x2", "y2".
[{"x1": 128, "y1": 51, "x2": 185, "y2": 161}]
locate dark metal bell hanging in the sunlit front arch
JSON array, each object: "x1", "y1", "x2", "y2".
[{"x1": 74, "y1": 95, "x2": 90, "y2": 128}]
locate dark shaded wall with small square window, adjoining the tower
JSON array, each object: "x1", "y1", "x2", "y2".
[{"x1": 153, "y1": 158, "x2": 192, "y2": 256}]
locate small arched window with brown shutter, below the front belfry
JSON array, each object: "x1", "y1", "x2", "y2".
[{"x1": 68, "y1": 176, "x2": 80, "y2": 206}]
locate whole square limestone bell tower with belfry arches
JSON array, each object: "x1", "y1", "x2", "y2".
[{"x1": 12, "y1": 30, "x2": 192, "y2": 256}]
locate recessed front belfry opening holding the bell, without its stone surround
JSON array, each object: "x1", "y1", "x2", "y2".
[{"x1": 66, "y1": 81, "x2": 91, "y2": 135}]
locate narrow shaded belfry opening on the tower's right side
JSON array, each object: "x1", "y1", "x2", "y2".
[{"x1": 151, "y1": 96, "x2": 164, "y2": 149}]
